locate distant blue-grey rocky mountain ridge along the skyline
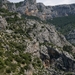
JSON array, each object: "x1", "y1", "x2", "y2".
[{"x1": 1, "y1": 0, "x2": 75, "y2": 20}]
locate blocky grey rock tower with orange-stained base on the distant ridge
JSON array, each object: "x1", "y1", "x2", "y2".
[{"x1": 17, "y1": 0, "x2": 38, "y2": 16}]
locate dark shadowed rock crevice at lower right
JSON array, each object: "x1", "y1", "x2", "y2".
[{"x1": 40, "y1": 46, "x2": 75, "y2": 72}]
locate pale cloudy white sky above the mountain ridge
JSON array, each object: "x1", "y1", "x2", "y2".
[{"x1": 9, "y1": 0, "x2": 75, "y2": 6}]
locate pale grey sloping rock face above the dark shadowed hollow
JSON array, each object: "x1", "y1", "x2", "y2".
[{"x1": 24, "y1": 21, "x2": 70, "y2": 47}]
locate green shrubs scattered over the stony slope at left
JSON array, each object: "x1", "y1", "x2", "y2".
[{"x1": 0, "y1": 9, "x2": 42, "y2": 75}]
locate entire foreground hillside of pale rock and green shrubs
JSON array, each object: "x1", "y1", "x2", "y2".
[{"x1": 0, "y1": 5, "x2": 75, "y2": 75}]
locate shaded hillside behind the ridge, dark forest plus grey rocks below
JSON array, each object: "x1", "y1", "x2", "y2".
[{"x1": 47, "y1": 15, "x2": 75, "y2": 44}]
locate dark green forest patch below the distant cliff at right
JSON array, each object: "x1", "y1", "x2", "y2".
[{"x1": 47, "y1": 15, "x2": 75, "y2": 35}]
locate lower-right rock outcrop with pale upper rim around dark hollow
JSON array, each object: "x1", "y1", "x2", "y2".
[{"x1": 40, "y1": 46, "x2": 75, "y2": 75}]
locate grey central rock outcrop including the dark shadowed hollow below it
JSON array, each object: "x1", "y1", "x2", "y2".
[{"x1": 22, "y1": 20, "x2": 75, "y2": 75}]
